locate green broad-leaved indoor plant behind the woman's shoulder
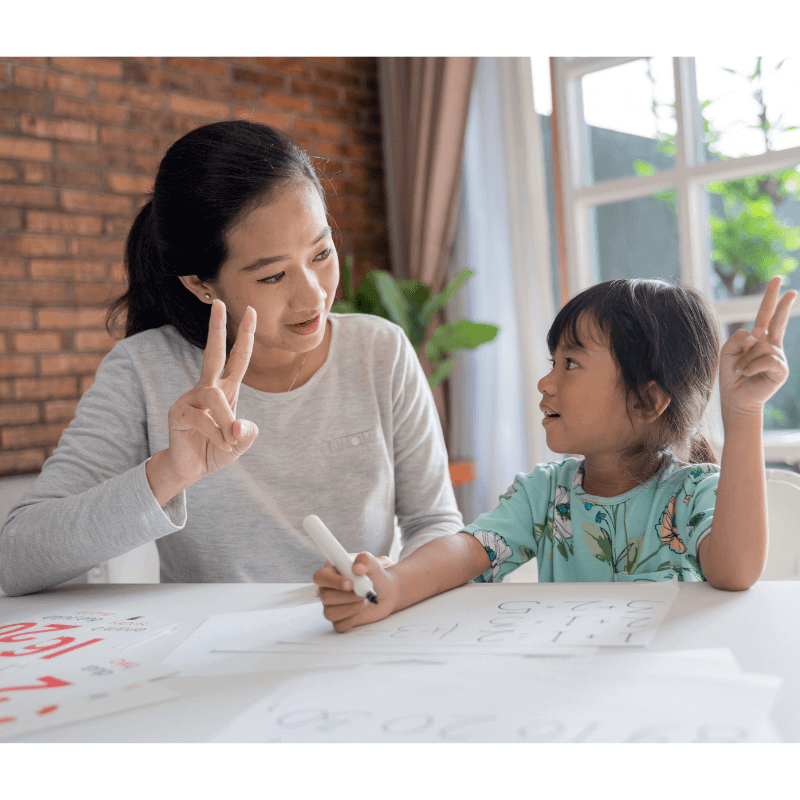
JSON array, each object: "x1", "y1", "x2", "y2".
[{"x1": 331, "y1": 256, "x2": 499, "y2": 389}]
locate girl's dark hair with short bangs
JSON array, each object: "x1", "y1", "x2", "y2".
[{"x1": 547, "y1": 279, "x2": 719, "y2": 481}]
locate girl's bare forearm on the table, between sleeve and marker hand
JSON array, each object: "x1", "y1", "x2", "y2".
[{"x1": 389, "y1": 533, "x2": 491, "y2": 611}]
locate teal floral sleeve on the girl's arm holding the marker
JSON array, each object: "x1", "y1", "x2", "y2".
[{"x1": 463, "y1": 465, "x2": 549, "y2": 583}]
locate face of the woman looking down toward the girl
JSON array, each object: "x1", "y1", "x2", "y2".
[{"x1": 210, "y1": 180, "x2": 339, "y2": 361}]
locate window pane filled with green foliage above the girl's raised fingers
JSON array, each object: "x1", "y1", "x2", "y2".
[{"x1": 706, "y1": 168, "x2": 800, "y2": 300}]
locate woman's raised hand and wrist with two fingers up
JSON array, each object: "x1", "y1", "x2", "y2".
[{"x1": 146, "y1": 300, "x2": 258, "y2": 505}]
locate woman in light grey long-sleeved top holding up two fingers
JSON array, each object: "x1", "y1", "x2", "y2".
[{"x1": 0, "y1": 121, "x2": 462, "y2": 595}]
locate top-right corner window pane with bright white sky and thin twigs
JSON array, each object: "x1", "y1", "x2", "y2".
[{"x1": 695, "y1": 56, "x2": 800, "y2": 160}]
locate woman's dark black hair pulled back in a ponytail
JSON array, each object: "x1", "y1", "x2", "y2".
[{"x1": 106, "y1": 120, "x2": 327, "y2": 347}]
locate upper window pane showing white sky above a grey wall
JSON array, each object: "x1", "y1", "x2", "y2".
[{"x1": 581, "y1": 57, "x2": 676, "y2": 183}]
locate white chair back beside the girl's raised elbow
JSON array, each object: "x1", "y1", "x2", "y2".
[{"x1": 761, "y1": 469, "x2": 800, "y2": 581}]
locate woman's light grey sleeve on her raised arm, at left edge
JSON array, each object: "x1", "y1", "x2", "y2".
[{"x1": 0, "y1": 342, "x2": 186, "y2": 595}]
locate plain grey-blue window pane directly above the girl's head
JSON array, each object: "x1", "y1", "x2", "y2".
[{"x1": 589, "y1": 191, "x2": 681, "y2": 282}]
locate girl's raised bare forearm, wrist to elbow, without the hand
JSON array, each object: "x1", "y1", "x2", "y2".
[{"x1": 699, "y1": 415, "x2": 767, "y2": 591}]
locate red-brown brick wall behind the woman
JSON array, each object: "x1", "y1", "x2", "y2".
[{"x1": 0, "y1": 57, "x2": 389, "y2": 476}]
